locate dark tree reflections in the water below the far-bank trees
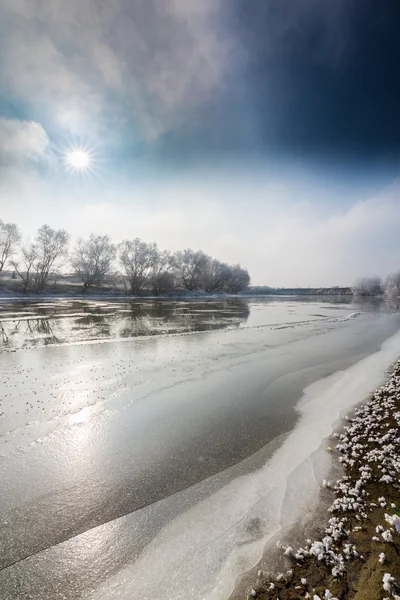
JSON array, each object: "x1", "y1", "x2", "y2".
[{"x1": 0, "y1": 298, "x2": 250, "y2": 348}]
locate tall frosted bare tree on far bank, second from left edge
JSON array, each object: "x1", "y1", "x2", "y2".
[{"x1": 12, "y1": 225, "x2": 69, "y2": 292}]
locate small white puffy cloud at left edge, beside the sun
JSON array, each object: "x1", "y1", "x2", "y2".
[{"x1": 0, "y1": 118, "x2": 49, "y2": 165}]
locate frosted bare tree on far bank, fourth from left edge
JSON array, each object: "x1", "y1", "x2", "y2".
[{"x1": 119, "y1": 238, "x2": 160, "y2": 295}]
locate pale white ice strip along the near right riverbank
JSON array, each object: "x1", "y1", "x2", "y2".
[{"x1": 82, "y1": 334, "x2": 400, "y2": 600}]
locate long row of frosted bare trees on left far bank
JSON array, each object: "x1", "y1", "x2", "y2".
[{"x1": 0, "y1": 219, "x2": 250, "y2": 296}]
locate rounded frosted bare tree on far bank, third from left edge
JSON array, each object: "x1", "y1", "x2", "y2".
[{"x1": 71, "y1": 233, "x2": 116, "y2": 289}]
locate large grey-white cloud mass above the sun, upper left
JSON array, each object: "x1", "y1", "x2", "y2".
[{"x1": 0, "y1": 0, "x2": 234, "y2": 139}]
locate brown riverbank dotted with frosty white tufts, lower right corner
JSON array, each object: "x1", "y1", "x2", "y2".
[{"x1": 248, "y1": 361, "x2": 400, "y2": 600}]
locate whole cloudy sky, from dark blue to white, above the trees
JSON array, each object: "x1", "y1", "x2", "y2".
[{"x1": 0, "y1": 0, "x2": 400, "y2": 286}]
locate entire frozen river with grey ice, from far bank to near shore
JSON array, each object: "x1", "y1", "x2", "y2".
[{"x1": 0, "y1": 298, "x2": 400, "y2": 600}]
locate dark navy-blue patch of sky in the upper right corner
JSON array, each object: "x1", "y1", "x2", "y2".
[{"x1": 225, "y1": 0, "x2": 400, "y2": 156}]
